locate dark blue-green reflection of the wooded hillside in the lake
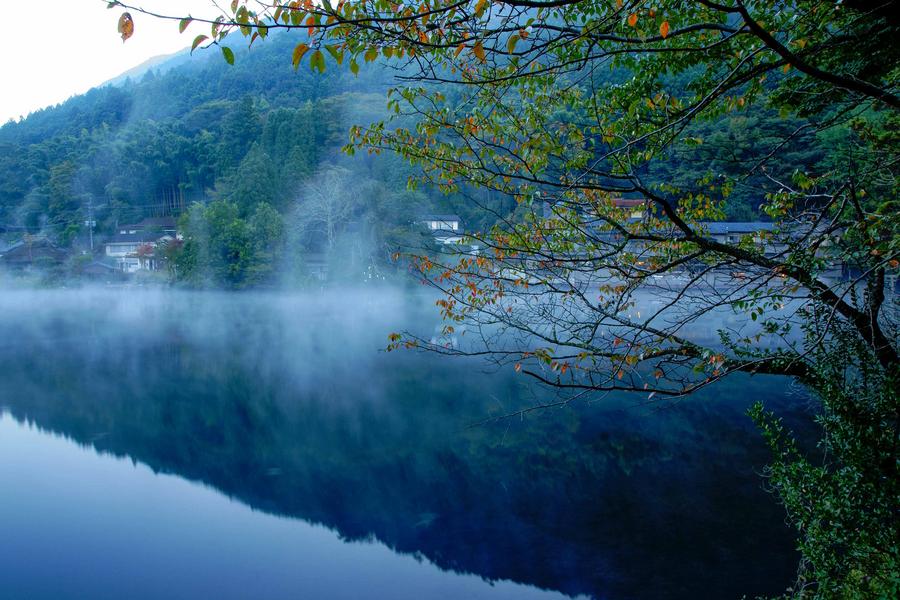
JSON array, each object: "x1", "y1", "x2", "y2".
[{"x1": 0, "y1": 290, "x2": 816, "y2": 597}]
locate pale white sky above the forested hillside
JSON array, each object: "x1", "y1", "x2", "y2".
[{"x1": 0, "y1": 0, "x2": 217, "y2": 125}]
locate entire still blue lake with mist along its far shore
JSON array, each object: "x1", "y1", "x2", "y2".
[{"x1": 0, "y1": 289, "x2": 809, "y2": 599}]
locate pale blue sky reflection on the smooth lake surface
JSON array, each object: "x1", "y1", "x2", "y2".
[{"x1": 0, "y1": 416, "x2": 562, "y2": 600}]
